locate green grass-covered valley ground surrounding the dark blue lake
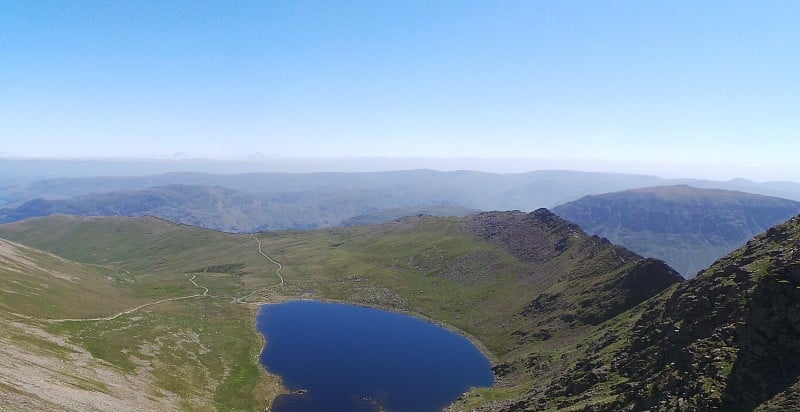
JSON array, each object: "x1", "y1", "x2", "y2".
[{"x1": 0, "y1": 214, "x2": 680, "y2": 410}]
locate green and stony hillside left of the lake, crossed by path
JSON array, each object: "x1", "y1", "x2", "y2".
[{"x1": 0, "y1": 217, "x2": 281, "y2": 411}]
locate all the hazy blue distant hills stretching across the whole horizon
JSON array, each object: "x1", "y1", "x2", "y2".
[{"x1": 0, "y1": 170, "x2": 800, "y2": 232}]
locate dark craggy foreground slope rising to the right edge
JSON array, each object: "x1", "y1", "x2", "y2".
[{"x1": 472, "y1": 212, "x2": 800, "y2": 411}]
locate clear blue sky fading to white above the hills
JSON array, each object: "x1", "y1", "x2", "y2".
[{"x1": 0, "y1": 0, "x2": 800, "y2": 180}]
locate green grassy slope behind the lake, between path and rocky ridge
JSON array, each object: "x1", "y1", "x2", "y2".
[{"x1": 253, "y1": 217, "x2": 528, "y2": 352}]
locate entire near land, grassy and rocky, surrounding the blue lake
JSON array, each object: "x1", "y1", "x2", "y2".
[{"x1": 0, "y1": 192, "x2": 800, "y2": 411}]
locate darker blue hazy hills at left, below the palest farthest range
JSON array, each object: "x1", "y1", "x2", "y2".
[{"x1": 0, "y1": 185, "x2": 446, "y2": 232}]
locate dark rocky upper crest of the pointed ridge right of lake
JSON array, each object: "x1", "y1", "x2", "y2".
[{"x1": 467, "y1": 209, "x2": 681, "y2": 325}]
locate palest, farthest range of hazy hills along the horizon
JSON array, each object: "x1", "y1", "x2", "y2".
[{"x1": 0, "y1": 170, "x2": 672, "y2": 210}]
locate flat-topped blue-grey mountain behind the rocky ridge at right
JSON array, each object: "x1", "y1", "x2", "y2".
[{"x1": 554, "y1": 186, "x2": 800, "y2": 277}]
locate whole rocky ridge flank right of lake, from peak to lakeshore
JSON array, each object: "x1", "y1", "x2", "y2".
[{"x1": 455, "y1": 209, "x2": 682, "y2": 411}]
